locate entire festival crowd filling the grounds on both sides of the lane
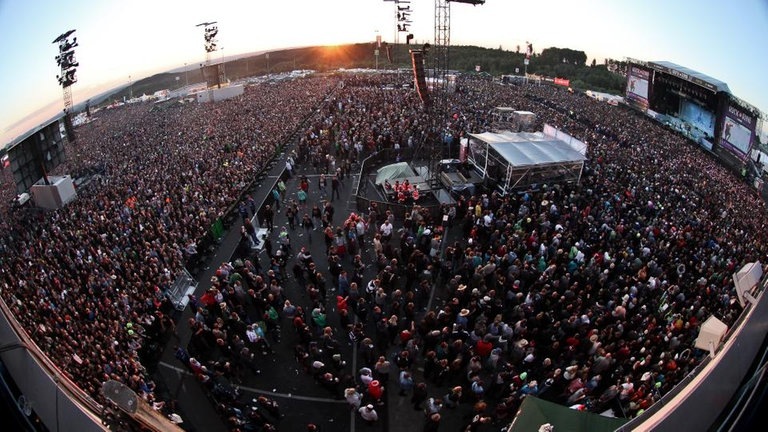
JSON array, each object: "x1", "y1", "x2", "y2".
[{"x1": 2, "y1": 68, "x2": 768, "y2": 431}]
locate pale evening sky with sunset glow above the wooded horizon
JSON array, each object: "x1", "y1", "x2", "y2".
[{"x1": 0, "y1": 0, "x2": 768, "y2": 146}]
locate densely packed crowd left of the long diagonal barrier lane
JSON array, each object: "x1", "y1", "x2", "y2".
[{"x1": 0, "y1": 79, "x2": 335, "y2": 416}]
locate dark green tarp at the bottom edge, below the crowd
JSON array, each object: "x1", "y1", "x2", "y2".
[{"x1": 507, "y1": 396, "x2": 628, "y2": 432}]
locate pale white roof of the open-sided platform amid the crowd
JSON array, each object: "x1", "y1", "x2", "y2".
[{"x1": 470, "y1": 131, "x2": 587, "y2": 167}]
